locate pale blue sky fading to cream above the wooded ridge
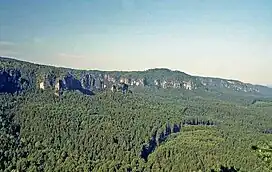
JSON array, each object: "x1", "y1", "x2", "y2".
[{"x1": 0, "y1": 0, "x2": 272, "y2": 84}]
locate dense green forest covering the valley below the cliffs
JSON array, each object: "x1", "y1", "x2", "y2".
[{"x1": 0, "y1": 57, "x2": 272, "y2": 172}]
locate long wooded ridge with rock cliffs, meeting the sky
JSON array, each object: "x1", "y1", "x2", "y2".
[{"x1": 0, "y1": 57, "x2": 272, "y2": 96}]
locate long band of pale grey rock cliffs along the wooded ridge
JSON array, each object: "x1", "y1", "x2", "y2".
[{"x1": 37, "y1": 72, "x2": 260, "y2": 96}]
